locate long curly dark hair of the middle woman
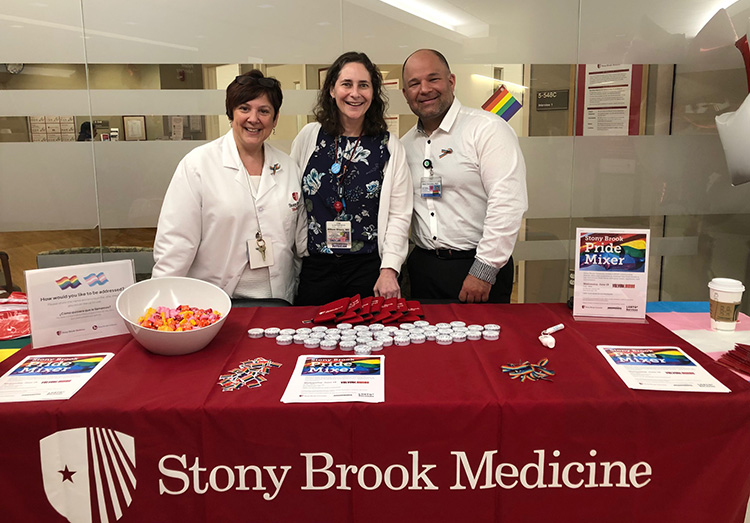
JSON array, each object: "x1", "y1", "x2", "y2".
[{"x1": 313, "y1": 51, "x2": 388, "y2": 136}]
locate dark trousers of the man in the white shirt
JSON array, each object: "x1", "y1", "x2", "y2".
[{"x1": 406, "y1": 247, "x2": 513, "y2": 303}]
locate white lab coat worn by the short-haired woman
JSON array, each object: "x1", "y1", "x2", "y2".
[{"x1": 152, "y1": 130, "x2": 307, "y2": 305}]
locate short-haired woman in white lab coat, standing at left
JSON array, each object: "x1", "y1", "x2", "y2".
[{"x1": 153, "y1": 70, "x2": 307, "y2": 303}]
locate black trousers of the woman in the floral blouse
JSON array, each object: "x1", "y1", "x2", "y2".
[{"x1": 294, "y1": 253, "x2": 380, "y2": 305}]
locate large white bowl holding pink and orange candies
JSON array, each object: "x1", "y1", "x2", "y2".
[{"x1": 117, "y1": 276, "x2": 232, "y2": 356}]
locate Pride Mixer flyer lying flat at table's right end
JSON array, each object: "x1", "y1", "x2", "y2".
[{"x1": 596, "y1": 345, "x2": 731, "y2": 392}]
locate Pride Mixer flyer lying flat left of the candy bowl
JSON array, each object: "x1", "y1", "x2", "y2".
[{"x1": 0, "y1": 352, "x2": 114, "y2": 403}]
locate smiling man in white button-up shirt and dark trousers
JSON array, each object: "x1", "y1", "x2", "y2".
[{"x1": 401, "y1": 49, "x2": 528, "y2": 303}]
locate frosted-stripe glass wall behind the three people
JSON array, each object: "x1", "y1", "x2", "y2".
[{"x1": 0, "y1": 0, "x2": 750, "y2": 313}]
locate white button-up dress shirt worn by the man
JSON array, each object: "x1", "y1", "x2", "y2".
[{"x1": 401, "y1": 98, "x2": 528, "y2": 283}]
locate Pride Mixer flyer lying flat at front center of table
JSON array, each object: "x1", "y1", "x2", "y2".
[{"x1": 281, "y1": 354, "x2": 385, "y2": 403}]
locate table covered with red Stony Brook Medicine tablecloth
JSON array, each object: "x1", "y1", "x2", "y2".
[{"x1": 0, "y1": 304, "x2": 750, "y2": 523}]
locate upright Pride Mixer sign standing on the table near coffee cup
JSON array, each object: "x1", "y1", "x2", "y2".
[{"x1": 573, "y1": 228, "x2": 649, "y2": 320}]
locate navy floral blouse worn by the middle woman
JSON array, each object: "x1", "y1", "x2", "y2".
[{"x1": 302, "y1": 129, "x2": 391, "y2": 254}]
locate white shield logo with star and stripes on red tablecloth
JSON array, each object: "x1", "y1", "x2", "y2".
[{"x1": 39, "y1": 427, "x2": 136, "y2": 523}]
